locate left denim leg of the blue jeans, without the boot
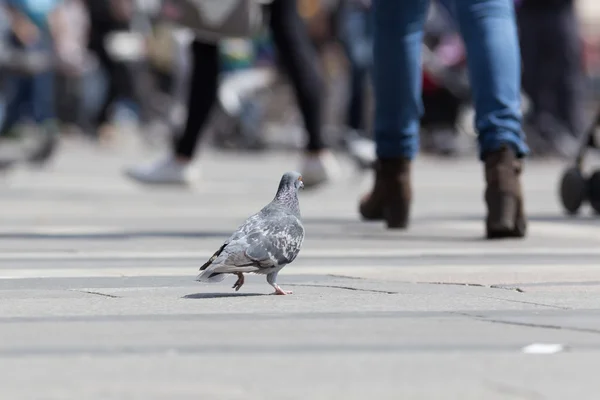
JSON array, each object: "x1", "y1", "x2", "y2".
[{"x1": 372, "y1": 0, "x2": 429, "y2": 160}]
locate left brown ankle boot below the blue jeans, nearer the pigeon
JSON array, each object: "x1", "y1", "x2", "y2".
[{"x1": 360, "y1": 158, "x2": 412, "y2": 228}]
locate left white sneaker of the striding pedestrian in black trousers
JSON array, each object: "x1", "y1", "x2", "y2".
[{"x1": 125, "y1": 157, "x2": 198, "y2": 185}]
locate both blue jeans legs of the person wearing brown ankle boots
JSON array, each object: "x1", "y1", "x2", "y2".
[{"x1": 373, "y1": 0, "x2": 529, "y2": 160}]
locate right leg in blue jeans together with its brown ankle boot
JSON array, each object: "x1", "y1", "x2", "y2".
[{"x1": 455, "y1": 0, "x2": 529, "y2": 238}]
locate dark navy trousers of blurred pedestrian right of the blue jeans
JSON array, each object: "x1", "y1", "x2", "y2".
[{"x1": 518, "y1": 7, "x2": 584, "y2": 136}]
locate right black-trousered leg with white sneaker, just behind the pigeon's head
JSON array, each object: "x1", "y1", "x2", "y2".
[{"x1": 269, "y1": 0, "x2": 338, "y2": 188}]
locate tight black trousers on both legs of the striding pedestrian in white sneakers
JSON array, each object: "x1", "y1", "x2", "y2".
[{"x1": 175, "y1": 0, "x2": 325, "y2": 158}]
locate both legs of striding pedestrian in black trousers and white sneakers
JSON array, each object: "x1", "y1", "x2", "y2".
[{"x1": 127, "y1": 0, "x2": 338, "y2": 187}]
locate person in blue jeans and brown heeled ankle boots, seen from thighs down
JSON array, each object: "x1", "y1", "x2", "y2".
[{"x1": 360, "y1": 0, "x2": 529, "y2": 238}]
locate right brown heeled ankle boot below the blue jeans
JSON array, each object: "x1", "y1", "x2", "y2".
[{"x1": 484, "y1": 146, "x2": 527, "y2": 239}]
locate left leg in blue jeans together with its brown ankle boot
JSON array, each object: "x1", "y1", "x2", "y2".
[{"x1": 360, "y1": 0, "x2": 429, "y2": 228}]
